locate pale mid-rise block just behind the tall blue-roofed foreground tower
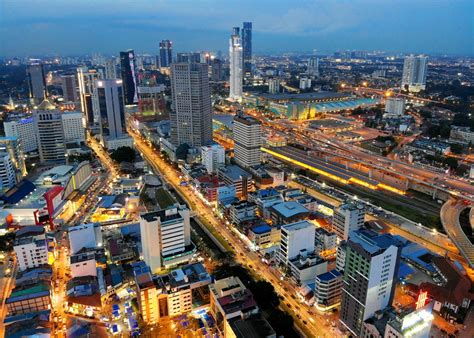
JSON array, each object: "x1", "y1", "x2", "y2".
[{"x1": 332, "y1": 202, "x2": 365, "y2": 241}]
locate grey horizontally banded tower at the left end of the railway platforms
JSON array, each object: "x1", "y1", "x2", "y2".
[{"x1": 233, "y1": 114, "x2": 262, "y2": 167}]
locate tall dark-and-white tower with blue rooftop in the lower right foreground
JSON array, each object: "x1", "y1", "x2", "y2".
[{"x1": 339, "y1": 230, "x2": 401, "y2": 337}]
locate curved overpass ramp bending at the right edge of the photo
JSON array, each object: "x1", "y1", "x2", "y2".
[{"x1": 441, "y1": 198, "x2": 474, "y2": 268}]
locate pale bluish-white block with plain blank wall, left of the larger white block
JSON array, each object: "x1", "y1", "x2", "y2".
[{"x1": 68, "y1": 223, "x2": 102, "y2": 254}]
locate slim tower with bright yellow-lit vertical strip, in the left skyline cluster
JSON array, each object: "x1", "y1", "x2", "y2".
[{"x1": 77, "y1": 67, "x2": 104, "y2": 126}]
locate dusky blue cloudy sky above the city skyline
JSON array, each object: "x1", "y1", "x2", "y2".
[{"x1": 0, "y1": 0, "x2": 474, "y2": 56}]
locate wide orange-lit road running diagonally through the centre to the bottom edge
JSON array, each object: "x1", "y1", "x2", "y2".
[{"x1": 131, "y1": 133, "x2": 341, "y2": 337}]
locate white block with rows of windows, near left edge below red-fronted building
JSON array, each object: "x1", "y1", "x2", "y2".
[{"x1": 13, "y1": 227, "x2": 48, "y2": 271}]
